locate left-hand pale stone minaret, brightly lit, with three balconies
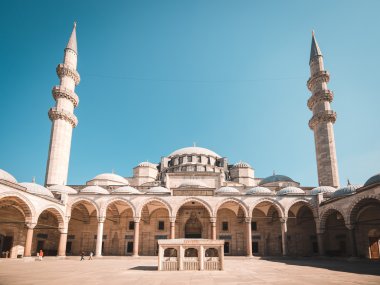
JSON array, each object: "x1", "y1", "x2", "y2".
[{"x1": 45, "y1": 23, "x2": 80, "y2": 185}]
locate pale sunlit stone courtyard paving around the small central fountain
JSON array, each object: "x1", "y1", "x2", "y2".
[{"x1": 0, "y1": 257, "x2": 380, "y2": 285}]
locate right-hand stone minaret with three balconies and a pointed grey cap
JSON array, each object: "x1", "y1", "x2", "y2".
[{"x1": 307, "y1": 31, "x2": 339, "y2": 187}]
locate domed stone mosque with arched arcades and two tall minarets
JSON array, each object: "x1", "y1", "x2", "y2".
[{"x1": 0, "y1": 24, "x2": 380, "y2": 259}]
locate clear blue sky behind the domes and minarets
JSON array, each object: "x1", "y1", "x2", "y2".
[{"x1": 0, "y1": 0, "x2": 380, "y2": 186}]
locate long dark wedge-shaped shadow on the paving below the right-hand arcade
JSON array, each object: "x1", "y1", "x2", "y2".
[{"x1": 260, "y1": 255, "x2": 380, "y2": 276}]
